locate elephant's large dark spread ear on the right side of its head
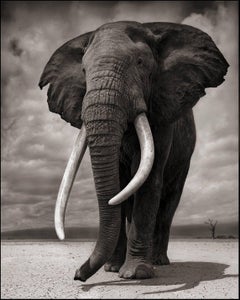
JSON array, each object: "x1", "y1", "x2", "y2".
[{"x1": 143, "y1": 23, "x2": 229, "y2": 122}]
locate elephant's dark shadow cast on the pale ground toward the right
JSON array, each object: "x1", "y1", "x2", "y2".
[{"x1": 82, "y1": 262, "x2": 238, "y2": 295}]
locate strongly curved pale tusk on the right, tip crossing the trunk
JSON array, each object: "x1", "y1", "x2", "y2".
[{"x1": 108, "y1": 113, "x2": 154, "y2": 205}]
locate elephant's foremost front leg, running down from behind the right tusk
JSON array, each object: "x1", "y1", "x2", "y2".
[{"x1": 119, "y1": 126, "x2": 172, "y2": 279}]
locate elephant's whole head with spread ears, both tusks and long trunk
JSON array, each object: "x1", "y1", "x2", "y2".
[{"x1": 39, "y1": 22, "x2": 228, "y2": 280}]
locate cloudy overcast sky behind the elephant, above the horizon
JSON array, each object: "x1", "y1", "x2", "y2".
[{"x1": 1, "y1": 1, "x2": 238, "y2": 230}]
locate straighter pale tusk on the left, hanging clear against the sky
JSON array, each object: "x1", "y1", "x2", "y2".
[{"x1": 54, "y1": 124, "x2": 87, "y2": 240}]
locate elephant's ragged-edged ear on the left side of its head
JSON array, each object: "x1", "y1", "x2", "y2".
[{"x1": 39, "y1": 32, "x2": 92, "y2": 128}]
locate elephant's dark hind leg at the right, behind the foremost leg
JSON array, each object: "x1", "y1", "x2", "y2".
[{"x1": 152, "y1": 163, "x2": 189, "y2": 265}]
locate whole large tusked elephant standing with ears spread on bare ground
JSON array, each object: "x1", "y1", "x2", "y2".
[{"x1": 39, "y1": 21, "x2": 229, "y2": 281}]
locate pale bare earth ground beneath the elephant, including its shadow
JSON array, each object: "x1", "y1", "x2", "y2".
[{"x1": 1, "y1": 239, "x2": 239, "y2": 299}]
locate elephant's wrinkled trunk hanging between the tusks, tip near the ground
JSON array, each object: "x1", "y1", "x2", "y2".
[{"x1": 75, "y1": 91, "x2": 127, "y2": 281}]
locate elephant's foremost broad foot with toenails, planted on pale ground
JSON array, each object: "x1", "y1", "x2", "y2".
[{"x1": 119, "y1": 259, "x2": 154, "y2": 279}]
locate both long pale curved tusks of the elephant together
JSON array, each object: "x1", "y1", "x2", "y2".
[{"x1": 54, "y1": 113, "x2": 154, "y2": 240}]
